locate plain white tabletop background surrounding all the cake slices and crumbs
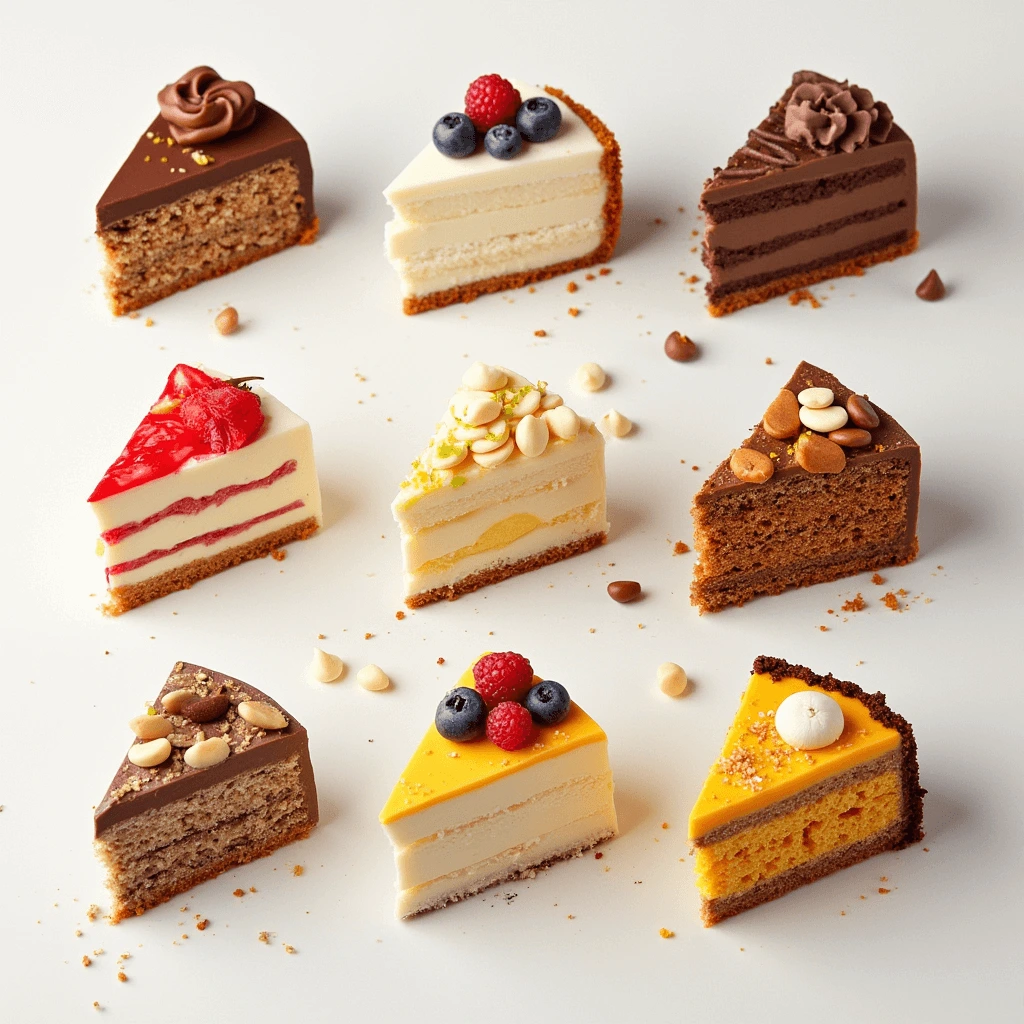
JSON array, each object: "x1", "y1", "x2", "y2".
[{"x1": 0, "y1": 0, "x2": 1024, "y2": 1022}]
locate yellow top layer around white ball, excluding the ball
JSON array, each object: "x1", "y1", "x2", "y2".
[{"x1": 689, "y1": 675, "x2": 900, "y2": 839}]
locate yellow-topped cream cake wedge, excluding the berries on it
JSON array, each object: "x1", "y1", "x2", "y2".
[{"x1": 380, "y1": 667, "x2": 618, "y2": 918}]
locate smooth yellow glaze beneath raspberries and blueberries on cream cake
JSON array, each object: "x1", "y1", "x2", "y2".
[{"x1": 380, "y1": 654, "x2": 608, "y2": 825}]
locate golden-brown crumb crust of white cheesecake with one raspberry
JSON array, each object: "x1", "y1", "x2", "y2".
[{"x1": 401, "y1": 85, "x2": 623, "y2": 316}]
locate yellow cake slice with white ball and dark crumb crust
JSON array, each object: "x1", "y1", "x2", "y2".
[{"x1": 689, "y1": 657, "x2": 925, "y2": 926}]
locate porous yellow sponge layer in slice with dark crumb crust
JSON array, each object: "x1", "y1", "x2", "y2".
[{"x1": 694, "y1": 772, "x2": 902, "y2": 900}]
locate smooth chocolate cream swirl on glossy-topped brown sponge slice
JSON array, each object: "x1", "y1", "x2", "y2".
[{"x1": 157, "y1": 67, "x2": 256, "y2": 145}]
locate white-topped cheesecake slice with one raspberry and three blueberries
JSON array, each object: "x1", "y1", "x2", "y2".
[{"x1": 384, "y1": 75, "x2": 623, "y2": 313}]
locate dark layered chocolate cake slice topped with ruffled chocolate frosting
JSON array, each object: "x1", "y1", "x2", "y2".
[{"x1": 700, "y1": 71, "x2": 918, "y2": 316}]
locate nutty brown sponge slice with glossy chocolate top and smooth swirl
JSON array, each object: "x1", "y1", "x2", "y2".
[{"x1": 96, "y1": 68, "x2": 317, "y2": 315}]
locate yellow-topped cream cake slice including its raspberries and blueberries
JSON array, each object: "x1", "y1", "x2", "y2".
[{"x1": 380, "y1": 652, "x2": 618, "y2": 918}]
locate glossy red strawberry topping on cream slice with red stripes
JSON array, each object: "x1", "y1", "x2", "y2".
[{"x1": 89, "y1": 362, "x2": 263, "y2": 502}]
